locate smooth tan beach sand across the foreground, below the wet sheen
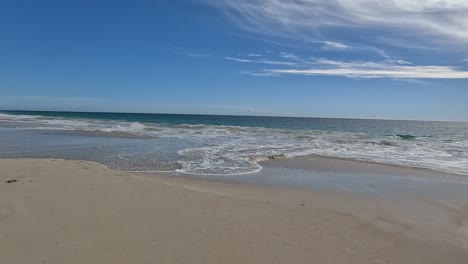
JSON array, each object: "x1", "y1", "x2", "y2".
[{"x1": 0, "y1": 159, "x2": 468, "y2": 264}]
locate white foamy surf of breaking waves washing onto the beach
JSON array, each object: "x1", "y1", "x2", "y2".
[{"x1": 0, "y1": 114, "x2": 468, "y2": 175}]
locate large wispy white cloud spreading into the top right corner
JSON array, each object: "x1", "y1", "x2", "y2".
[{"x1": 216, "y1": 0, "x2": 468, "y2": 48}]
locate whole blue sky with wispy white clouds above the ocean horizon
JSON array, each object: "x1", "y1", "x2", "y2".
[{"x1": 0, "y1": 0, "x2": 468, "y2": 121}]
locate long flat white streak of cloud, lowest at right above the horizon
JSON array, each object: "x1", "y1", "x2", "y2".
[{"x1": 261, "y1": 59, "x2": 468, "y2": 80}]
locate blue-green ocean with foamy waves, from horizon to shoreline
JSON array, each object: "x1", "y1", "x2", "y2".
[{"x1": 0, "y1": 111, "x2": 468, "y2": 177}]
